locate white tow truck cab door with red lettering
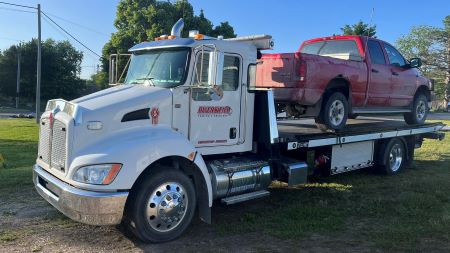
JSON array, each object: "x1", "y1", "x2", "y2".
[{"x1": 189, "y1": 50, "x2": 242, "y2": 147}]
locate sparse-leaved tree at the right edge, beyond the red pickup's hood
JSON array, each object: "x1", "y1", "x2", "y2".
[{"x1": 397, "y1": 16, "x2": 450, "y2": 106}]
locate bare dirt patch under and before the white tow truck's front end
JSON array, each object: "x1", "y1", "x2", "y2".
[{"x1": 0, "y1": 188, "x2": 373, "y2": 253}]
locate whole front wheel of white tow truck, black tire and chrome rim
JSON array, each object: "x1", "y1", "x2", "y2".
[{"x1": 126, "y1": 166, "x2": 197, "y2": 243}]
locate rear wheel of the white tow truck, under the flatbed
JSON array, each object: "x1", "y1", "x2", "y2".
[{"x1": 378, "y1": 138, "x2": 407, "y2": 175}]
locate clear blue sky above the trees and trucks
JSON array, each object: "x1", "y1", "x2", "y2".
[{"x1": 0, "y1": 0, "x2": 450, "y2": 78}]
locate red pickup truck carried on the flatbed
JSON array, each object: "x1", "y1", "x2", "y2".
[{"x1": 256, "y1": 36, "x2": 432, "y2": 130}]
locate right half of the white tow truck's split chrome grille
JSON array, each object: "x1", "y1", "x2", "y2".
[{"x1": 51, "y1": 120, "x2": 66, "y2": 169}]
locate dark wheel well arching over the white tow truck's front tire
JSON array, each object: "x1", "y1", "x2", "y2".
[{"x1": 125, "y1": 156, "x2": 211, "y2": 223}]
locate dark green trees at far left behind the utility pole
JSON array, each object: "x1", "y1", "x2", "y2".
[{"x1": 0, "y1": 39, "x2": 84, "y2": 104}]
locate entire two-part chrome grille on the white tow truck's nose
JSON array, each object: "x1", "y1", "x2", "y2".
[{"x1": 38, "y1": 118, "x2": 67, "y2": 172}]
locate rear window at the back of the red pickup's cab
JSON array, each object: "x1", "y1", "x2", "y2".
[{"x1": 301, "y1": 40, "x2": 362, "y2": 60}]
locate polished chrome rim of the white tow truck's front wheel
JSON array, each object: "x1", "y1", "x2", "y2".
[{"x1": 147, "y1": 182, "x2": 189, "y2": 232}]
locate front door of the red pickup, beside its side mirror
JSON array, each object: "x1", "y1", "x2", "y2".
[{"x1": 383, "y1": 43, "x2": 418, "y2": 107}]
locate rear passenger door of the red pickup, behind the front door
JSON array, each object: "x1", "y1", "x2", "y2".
[{"x1": 366, "y1": 40, "x2": 392, "y2": 107}]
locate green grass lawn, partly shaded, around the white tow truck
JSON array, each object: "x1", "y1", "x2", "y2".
[{"x1": 0, "y1": 119, "x2": 450, "y2": 252}]
